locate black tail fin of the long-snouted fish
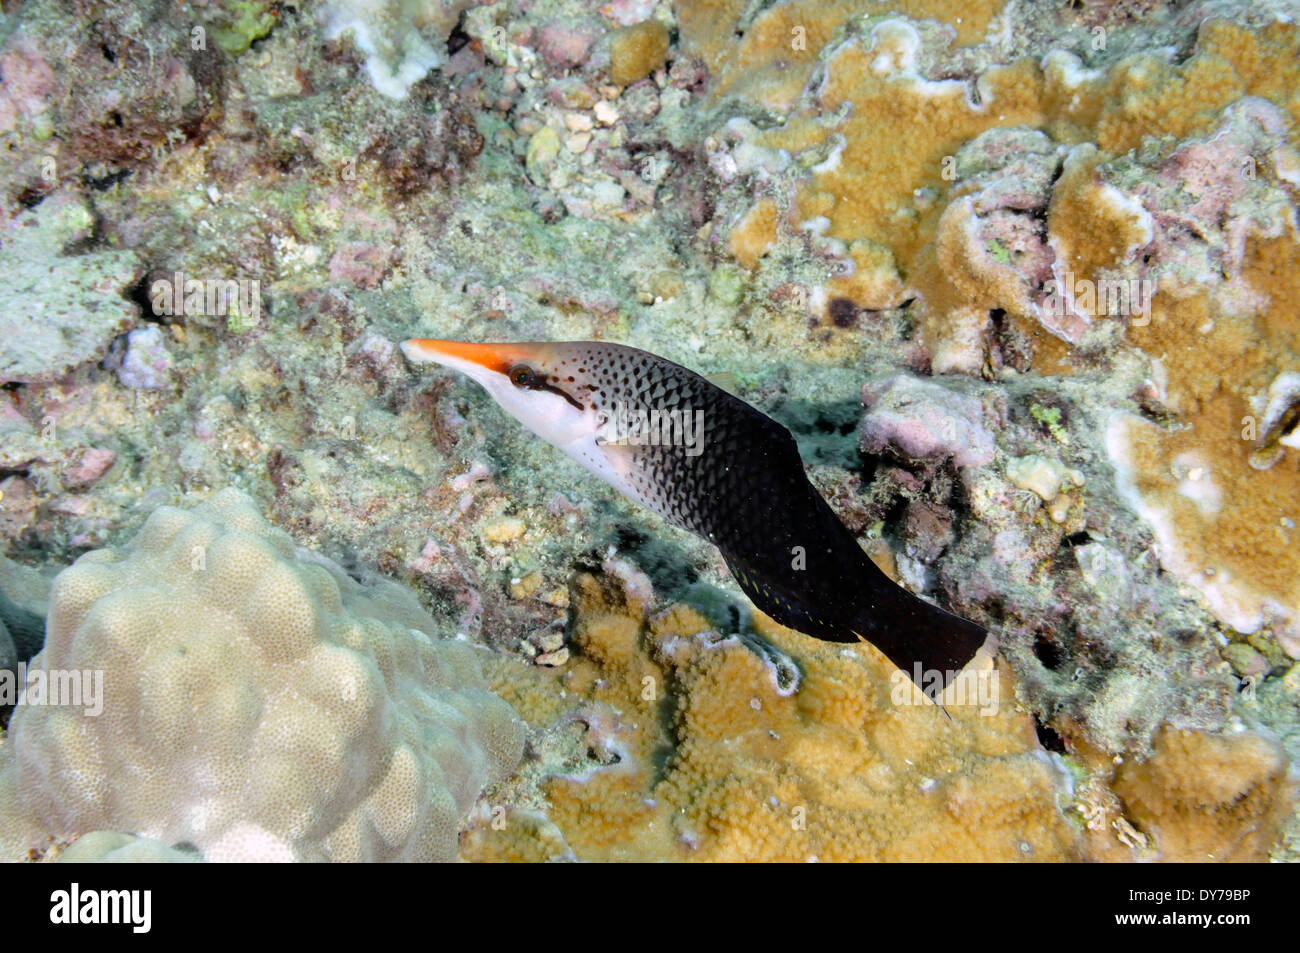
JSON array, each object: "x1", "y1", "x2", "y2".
[{"x1": 852, "y1": 589, "x2": 993, "y2": 703}]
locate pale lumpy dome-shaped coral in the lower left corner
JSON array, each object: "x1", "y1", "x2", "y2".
[{"x1": 0, "y1": 490, "x2": 524, "y2": 861}]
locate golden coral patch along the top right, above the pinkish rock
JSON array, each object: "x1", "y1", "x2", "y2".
[{"x1": 679, "y1": 0, "x2": 1300, "y2": 361}]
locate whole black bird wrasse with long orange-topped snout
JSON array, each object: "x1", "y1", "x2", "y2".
[{"x1": 402, "y1": 338, "x2": 988, "y2": 701}]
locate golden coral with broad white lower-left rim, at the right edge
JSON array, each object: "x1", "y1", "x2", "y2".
[{"x1": 1110, "y1": 235, "x2": 1300, "y2": 651}]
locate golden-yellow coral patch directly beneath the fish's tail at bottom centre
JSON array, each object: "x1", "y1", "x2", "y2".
[{"x1": 462, "y1": 576, "x2": 1076, "y2": 861}]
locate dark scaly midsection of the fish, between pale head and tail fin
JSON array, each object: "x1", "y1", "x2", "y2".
[{"x1": 556, "y1": 345, "x2": 893, "y2": 641}]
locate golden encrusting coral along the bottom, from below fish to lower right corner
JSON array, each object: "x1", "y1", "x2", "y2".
[{"x1": 463, "y1": 559, "x2": 1296, "y2": 861}]
